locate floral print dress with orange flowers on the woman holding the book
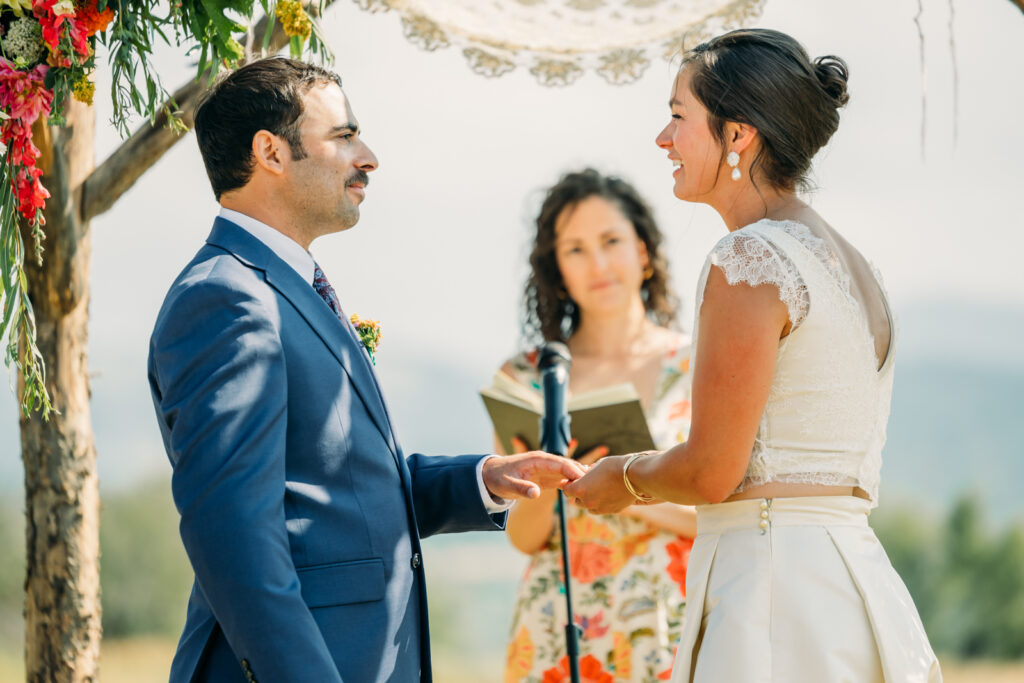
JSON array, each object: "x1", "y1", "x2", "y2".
[{"x1": 505, "y1": 339, "x2": 693, "y2": 683}]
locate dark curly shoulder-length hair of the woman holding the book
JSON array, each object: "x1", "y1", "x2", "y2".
[{"x1": 523, "y1": 168, "x2": 679, "y2": 345}]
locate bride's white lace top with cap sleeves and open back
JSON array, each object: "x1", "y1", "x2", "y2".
[{"x1": 693, "y1": 219, "x2": 895, "y2": 505}]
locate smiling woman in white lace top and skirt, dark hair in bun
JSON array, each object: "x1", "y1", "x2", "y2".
[{"x1": 565, "y1": 30, "x2": 941, "y2": 683}]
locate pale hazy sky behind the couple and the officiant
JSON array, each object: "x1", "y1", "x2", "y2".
[{"x1": 0, "y1": 0, "x2": 1024, "y2": 491}]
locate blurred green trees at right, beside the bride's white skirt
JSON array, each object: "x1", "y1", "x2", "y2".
[{"x1": 872, "y1": 495, "x2": 1024, "y2": 659}]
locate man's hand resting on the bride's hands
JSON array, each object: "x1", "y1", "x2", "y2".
[{"x1": 482, "y1": 451, "x2": 585, "y2": 500}]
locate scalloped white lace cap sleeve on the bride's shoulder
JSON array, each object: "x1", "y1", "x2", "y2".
[{"x1": 710, "y1": 229, "x2": 810, "y2": 330}]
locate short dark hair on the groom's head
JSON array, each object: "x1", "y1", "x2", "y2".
[{"x1": 196, "y1": 57, "x2": 341, "y2": 201}]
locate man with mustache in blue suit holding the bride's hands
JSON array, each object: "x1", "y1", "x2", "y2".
[{"x1": 148, "y1": 58, "x2": 583, "y2": 683}]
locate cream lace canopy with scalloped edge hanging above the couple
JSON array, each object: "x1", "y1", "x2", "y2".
[{"x1": 354, "y1": 0, "x2": 764, "y2": 85}]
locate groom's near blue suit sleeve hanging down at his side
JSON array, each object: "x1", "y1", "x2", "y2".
[{"x1": 150, "y1": 280, "x2": 341, "y2": 681}]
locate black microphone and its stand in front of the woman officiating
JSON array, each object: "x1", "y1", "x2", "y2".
[{"x1": 538, "y1": 342, "x2": 580, "y2": 683}]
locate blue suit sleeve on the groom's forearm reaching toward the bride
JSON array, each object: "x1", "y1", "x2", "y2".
[{"x1": 406, "y1": 454, "x2": 508, "y2": 539}]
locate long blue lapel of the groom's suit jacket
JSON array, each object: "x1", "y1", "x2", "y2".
[{"x1": 207, "y1": 222, "x2": 400, "y2": 468}]
